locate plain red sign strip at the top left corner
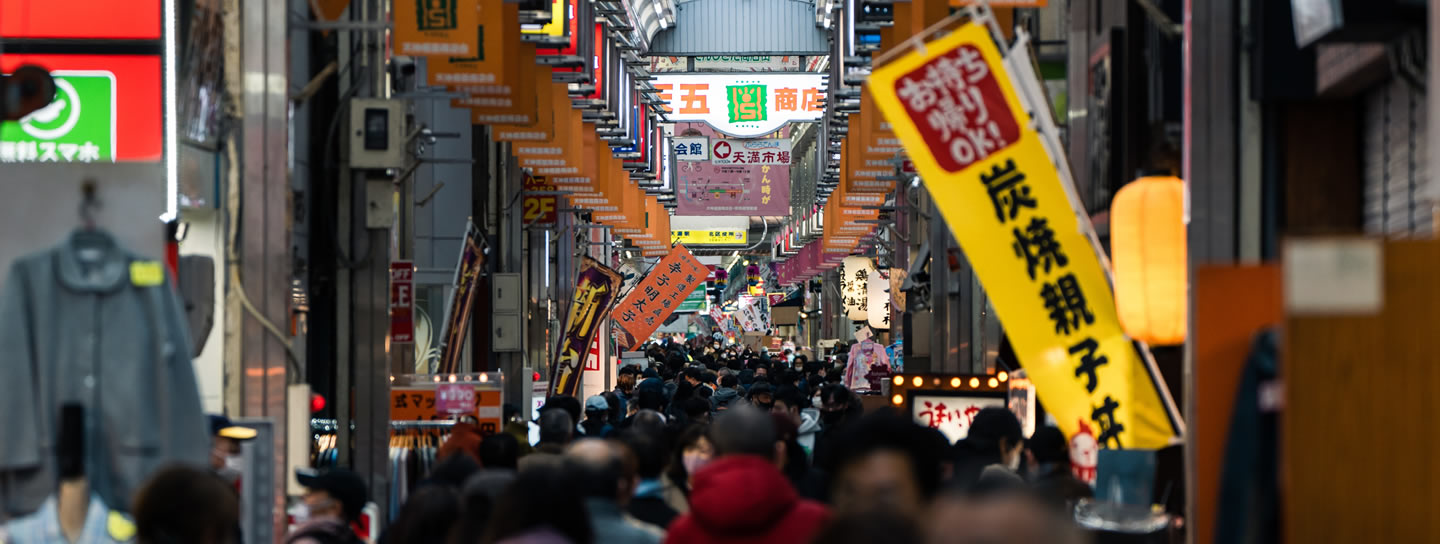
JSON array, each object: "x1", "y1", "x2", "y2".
[{"x1": 0, "y1": 0, "x2": 164, "y2": 40}]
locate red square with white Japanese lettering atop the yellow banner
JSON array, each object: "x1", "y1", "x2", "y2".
[{"x1": 896, "y1": 45, "x2": 1020, "y2": 173}]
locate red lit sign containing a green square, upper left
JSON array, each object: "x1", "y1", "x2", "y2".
[{"x1": 0, "y1": 53, "x2": 164, "y2": 163}]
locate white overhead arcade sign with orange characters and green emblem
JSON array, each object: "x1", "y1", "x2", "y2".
[{"x1": 654, "y1": 73, "x2": 825, "y2": 138}]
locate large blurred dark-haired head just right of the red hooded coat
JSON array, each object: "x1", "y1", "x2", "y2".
[{"x1": 829, "y1": 410, "x2": 946, "y2": 512}]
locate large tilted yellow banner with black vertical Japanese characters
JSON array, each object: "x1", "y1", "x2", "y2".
[{"x1": 868, "y1": 23, "x2": 1182, "y2": 449}]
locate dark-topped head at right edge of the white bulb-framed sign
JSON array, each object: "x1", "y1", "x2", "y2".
[{"x1": 955, "y1": 406, "x2": 1025, "y2": 488}]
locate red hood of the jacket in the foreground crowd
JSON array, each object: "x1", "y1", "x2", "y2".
[{"x1": 690, "y1": 455, "x2": 799, "y2": 534}]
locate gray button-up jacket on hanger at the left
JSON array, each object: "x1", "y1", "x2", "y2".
[{"x1": 0, "y1": 232, "x2": 210, "y2": 518}]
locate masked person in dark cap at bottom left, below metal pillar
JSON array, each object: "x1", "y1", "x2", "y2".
[{"x1": 285, "y1": 469, "x2": 369, "y2": 544}]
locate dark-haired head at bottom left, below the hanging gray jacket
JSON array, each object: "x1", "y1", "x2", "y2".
[{"x1": 131, "y1": 465, "x2": 240, "y2": 544}]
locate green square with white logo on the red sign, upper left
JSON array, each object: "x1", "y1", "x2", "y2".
[{"x1": 0, "y1": 71, "x2": 115, "y2": 163}]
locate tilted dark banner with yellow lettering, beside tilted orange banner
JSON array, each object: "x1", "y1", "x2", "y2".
[{"x1": 550, "y1": 258, "x2": 621, "y2": 396}]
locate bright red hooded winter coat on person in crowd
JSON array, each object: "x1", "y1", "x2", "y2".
[{"x1": 665, "y1": 455, "x2": 829, "y2": 544}]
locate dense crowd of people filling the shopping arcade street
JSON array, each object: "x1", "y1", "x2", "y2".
[{"x1": 115, "y1": 344, "x2": 1090, "y2": 544}]
